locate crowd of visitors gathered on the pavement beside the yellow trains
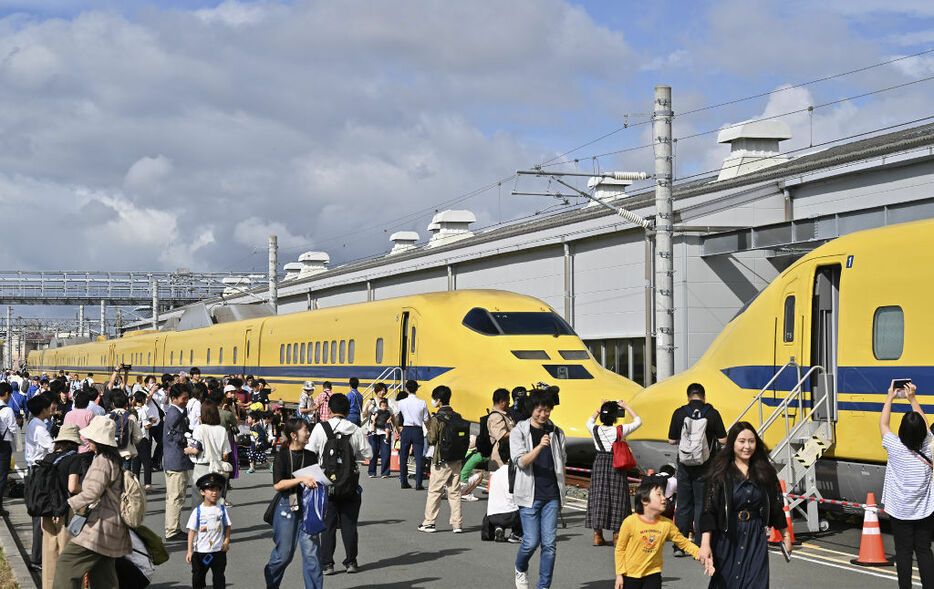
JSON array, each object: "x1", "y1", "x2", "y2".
[{"x1": 0, "y1": 367, "x2": 856, "y2": 589}]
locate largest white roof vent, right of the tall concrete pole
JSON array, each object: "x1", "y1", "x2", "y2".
[{"x1": 717, "y1": 120, "x2": 791, "y2": 180}]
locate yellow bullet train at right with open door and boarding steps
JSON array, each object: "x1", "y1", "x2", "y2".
[{"x1": 629, "y1": 220, "x2": 934, "y2": 501}]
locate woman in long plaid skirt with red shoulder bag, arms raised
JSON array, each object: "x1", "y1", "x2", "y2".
[{"x1": 584, "y1": 400, "x2": 642, "y2": 546}]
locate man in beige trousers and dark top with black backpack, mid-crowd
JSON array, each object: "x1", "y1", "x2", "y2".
[{"x1": 418, "y1": 385, "x2": 470, "y2": 534}]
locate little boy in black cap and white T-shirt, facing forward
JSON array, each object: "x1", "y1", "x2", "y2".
[{"x1": 185, "y1": 472, "x2": 230, "y2": 589}]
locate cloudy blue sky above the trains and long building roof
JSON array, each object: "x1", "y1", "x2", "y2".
[{"x1": 0, "y1": 0, "x2": 934, "y2": 271}]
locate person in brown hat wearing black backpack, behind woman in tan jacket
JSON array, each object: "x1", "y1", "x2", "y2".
[{"x1": 42, "y1": 424, "x2": 93, "y2": 589}]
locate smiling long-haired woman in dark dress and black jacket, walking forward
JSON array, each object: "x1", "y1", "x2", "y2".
[{"x1": 698, "y1": 421, "x2": 791, "y2": 589}]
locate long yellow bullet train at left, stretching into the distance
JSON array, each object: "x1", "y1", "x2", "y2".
[{"x1": 28, "y1": 290, "x2": 641, "y2": 454}]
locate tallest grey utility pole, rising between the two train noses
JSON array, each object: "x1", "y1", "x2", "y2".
[{"x1": 646, "y1": 86, "x2": 675, "y2": 385}]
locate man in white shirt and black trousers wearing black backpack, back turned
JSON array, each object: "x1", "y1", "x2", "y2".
[{"x1": 305, "y1": 393, "x2": 373, "y2": 575}]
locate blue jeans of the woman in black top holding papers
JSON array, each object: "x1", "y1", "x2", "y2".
[{"x1": 263, "y1": 497, "x2": 324, "y2": 589}]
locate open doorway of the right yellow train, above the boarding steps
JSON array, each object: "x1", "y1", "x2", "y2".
[{"x1": 811, "y1": 264, "x2": 840, "y2": 421}]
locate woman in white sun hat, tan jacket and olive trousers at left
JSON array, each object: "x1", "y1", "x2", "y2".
[{"x1": 53, "y1": 416, "x2": 132, "y2": 589}]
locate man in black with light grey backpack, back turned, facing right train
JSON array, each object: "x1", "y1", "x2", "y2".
[{"x1": 668, "y1": 382, "x2": 726, "y2": 556}]
